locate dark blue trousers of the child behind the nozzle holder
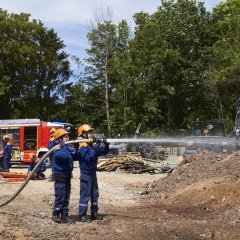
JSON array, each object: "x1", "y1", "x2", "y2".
[{"x1": 52, "y1": 180, "x2": 71, "y2": 217}]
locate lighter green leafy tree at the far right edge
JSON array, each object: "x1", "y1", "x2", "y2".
[{"x1": 206, "y1": 0, "x2": 240, "y2": 132}]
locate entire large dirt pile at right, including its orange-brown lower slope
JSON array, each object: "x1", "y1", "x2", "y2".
[{"x1": 144, "y1": 150, "x2": 240, "y2": 212}]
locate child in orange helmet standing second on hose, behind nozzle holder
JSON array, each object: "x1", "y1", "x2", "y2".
[{"x1": 52, "y1": 128, "x2": 73, "y2": 223}]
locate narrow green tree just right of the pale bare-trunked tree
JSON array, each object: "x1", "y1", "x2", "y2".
[{"x1": 111, "y1": 20, "x2": 136, "y2": 135}]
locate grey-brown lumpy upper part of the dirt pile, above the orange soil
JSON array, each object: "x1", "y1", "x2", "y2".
[{"x1": 146, "y1": 150, "x2": 240, "y2": 198}]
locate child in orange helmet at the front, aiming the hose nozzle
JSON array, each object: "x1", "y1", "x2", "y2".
[{"x1": 78, "y1": 124, "x2": 109, "y2": 222}]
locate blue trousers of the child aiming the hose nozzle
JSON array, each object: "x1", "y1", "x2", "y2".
[{"x1": 79, "y1": 173, "x2": 99, "y2": 217}]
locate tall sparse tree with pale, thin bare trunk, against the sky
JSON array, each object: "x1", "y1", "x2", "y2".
[{"x1": 84, "y1": 18, "x2": 116, "y2": 135}]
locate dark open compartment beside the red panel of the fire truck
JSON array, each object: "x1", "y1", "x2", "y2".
[{"x1": 24, "y1": 127, "x2": 37, "y2": 150}]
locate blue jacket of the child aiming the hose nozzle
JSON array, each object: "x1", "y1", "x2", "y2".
[{"x1": 78, "y1": 143, "x2": 109, "y2": 174}]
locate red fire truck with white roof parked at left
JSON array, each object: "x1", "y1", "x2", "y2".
[{"x1": 0, "y1": 119, "x2": 72, "y2": 164}]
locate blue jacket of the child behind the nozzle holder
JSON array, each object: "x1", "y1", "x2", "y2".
[{"x1": 53, "y1": 146, "x2": 73, "y2": 174}]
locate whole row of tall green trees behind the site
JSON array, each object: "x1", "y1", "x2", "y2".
[{"x1": 0, "y1": 0, "x2": 240, "y2": 136}]
